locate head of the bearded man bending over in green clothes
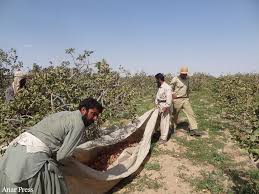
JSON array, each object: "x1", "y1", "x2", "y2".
[{"x1": 78, "y1": 98, "x2": 103, "y2": 127}]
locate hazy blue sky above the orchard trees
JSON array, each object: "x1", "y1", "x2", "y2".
[{"x1": 0, "y1": 0, "x2": 259, "y2": 75}]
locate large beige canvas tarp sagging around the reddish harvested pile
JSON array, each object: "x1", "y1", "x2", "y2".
[{"x1": 61, "y1": 109, "x2": 159, "y2": 194}]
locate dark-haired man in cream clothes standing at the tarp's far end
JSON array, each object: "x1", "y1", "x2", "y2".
[{"x1": 155, "y1": 73, "x2": 172, "y2": 144}]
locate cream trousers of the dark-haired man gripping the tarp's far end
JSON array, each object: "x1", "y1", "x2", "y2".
[{"x1": 160, "y1": 108, "x2": 171, "y2": 140}]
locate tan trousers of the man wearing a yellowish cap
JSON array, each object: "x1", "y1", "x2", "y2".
[{"x1": 173, "y1": 98, "x2": 198, "y2": 130}]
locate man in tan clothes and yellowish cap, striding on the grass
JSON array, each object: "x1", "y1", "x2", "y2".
[{"x1": 171, "y1": 67, "x2": 201, "y2": 136}]
